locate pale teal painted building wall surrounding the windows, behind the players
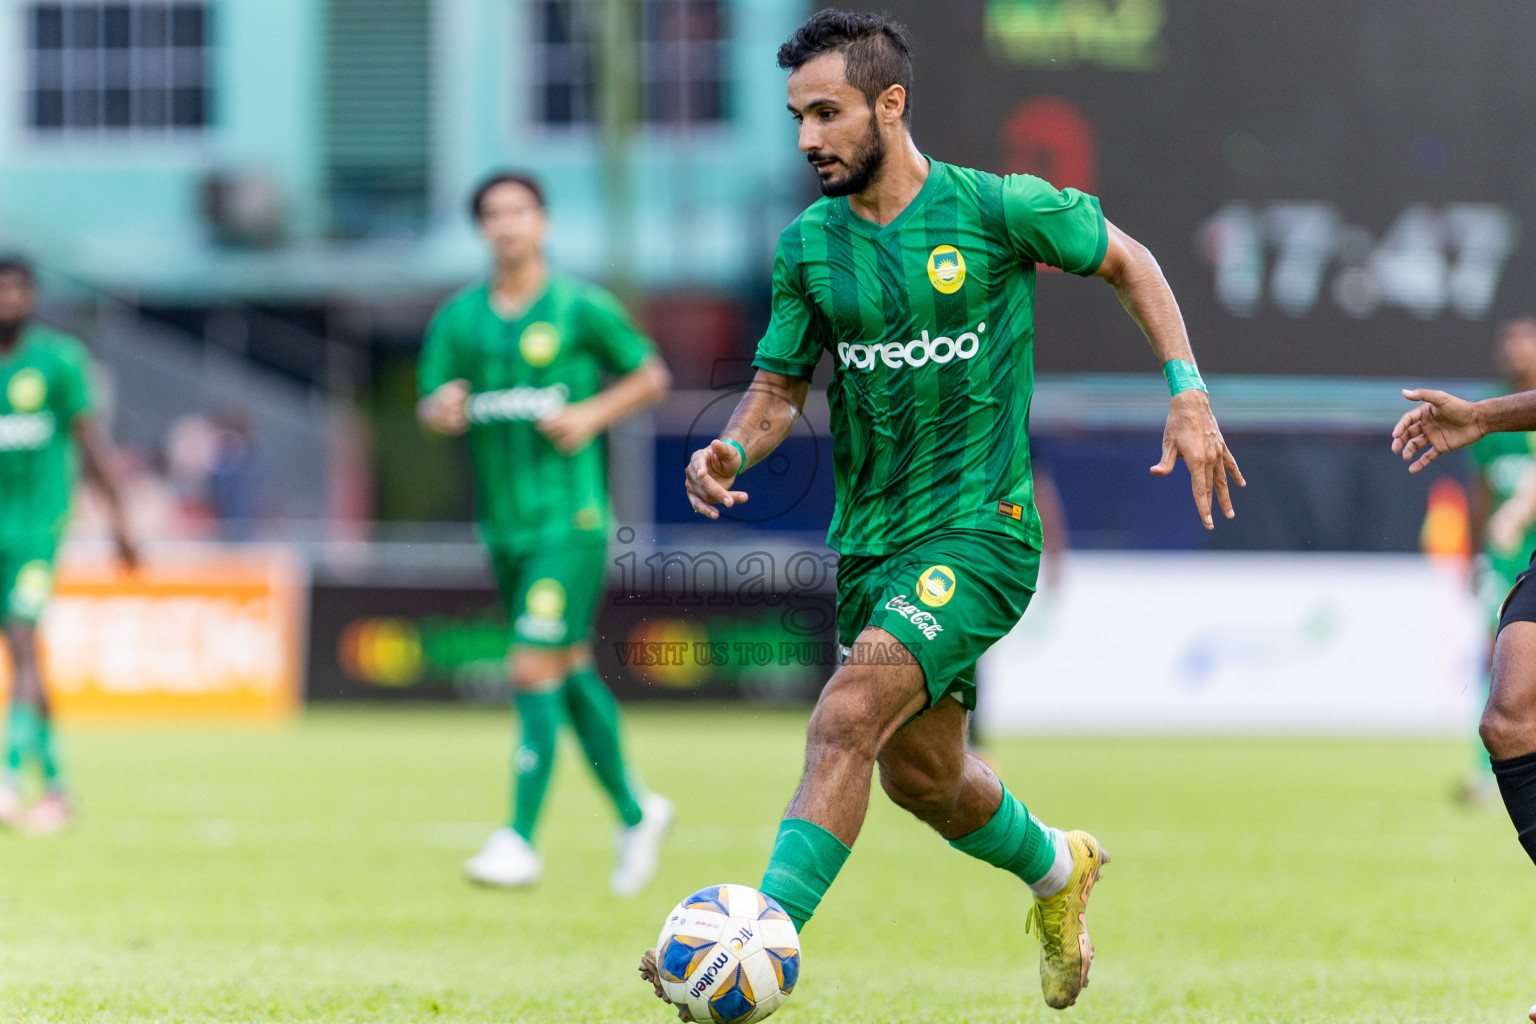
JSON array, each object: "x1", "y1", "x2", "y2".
[{"x1": 0, "y1": 0, "x2": 809, "y2": 299}]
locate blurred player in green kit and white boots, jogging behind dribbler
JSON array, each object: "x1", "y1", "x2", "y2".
[{"x1": 418, "y1": 173, "x2": 673, "y2": 895}]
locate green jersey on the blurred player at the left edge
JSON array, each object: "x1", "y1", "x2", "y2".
[{"x1": 0, "y1": 325, "x2": 92, "y2": 543}]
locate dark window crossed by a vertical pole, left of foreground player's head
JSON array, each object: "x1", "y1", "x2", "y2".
[{"x1": 531, "y1": 0, "x2": 730, "y2": 126}]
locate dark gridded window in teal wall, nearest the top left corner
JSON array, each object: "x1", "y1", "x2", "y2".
[{"x1": 26, "y1": 0, "x2": 212, "y2": 135}]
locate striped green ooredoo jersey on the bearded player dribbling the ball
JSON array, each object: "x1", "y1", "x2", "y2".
[{"x1": 754, "y1": 160, "x2": 1109, "y2": 554}]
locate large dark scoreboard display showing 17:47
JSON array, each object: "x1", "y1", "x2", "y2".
[{"x1": 849, "y1": 0, "x2": 1536, "y2": 378}]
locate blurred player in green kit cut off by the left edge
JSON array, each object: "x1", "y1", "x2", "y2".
[{"x1": 0, "y1": 256, "x2": 138, "y2": 834}]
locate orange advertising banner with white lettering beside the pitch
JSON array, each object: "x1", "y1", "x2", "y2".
[{"x1": 0, "y1": 550, "x2": 306, "y2": 720}]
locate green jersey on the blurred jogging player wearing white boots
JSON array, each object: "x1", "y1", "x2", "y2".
[{"x1": 418, "y1": 276, "x2": 654, "y2": 545}]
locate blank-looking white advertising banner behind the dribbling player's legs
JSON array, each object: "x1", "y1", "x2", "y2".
[{"x1": 978, "y1": 553, "x2": 1487, "y2": 735}]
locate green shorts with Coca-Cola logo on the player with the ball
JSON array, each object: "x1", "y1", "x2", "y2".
[{"x1": 837, "y1": 530, "x2": 1040, "y2": 708}]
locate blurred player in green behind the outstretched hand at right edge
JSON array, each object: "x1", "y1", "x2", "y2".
[{"x1": 1456, "y1": 318, "x2": 1536, "y2": 803}]
